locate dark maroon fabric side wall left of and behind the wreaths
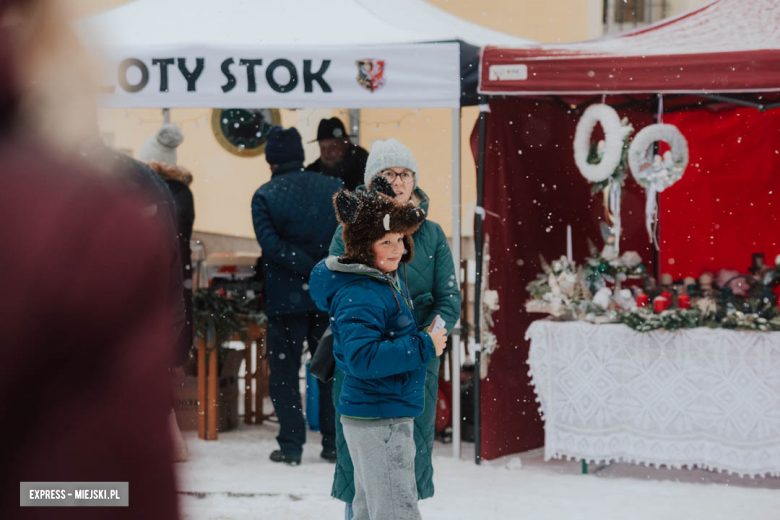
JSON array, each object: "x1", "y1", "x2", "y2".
[{"x1": 472, "y1": 98, "x2": 653, "y2": 460}]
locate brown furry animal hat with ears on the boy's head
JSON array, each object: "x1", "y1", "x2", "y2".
[{"x1": 333, "y1": 176, "x2": 425, "y2": 267}]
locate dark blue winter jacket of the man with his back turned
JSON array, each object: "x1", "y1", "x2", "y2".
[{"x1": 252, "y1": 162, "x2": 344, "y2": 316}]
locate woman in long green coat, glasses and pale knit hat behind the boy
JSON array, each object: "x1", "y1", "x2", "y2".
[{"x1": 330, "y1": 139, "x2": 461, "y2": 518}]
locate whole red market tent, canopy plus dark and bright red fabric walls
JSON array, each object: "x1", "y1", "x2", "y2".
[{"x1": 473, "y1": 0, "x2": 780, "y2": 459}]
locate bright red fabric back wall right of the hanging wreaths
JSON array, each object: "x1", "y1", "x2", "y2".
[{"x1": 659, "y1": 108, "x2": 780, "y2": 279}]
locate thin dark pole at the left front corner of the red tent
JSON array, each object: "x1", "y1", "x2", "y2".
[{"x1": 473, "y1": 96, "x2": 489, "y2": 464}]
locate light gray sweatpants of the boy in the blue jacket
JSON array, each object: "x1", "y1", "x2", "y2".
[{"x1": 341, "y1": 415, "x2": 422, "y2": 520}]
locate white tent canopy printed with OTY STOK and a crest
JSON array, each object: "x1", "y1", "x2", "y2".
[{"x1": 79, "y1": 0, "x2": 529, "y2": 108}]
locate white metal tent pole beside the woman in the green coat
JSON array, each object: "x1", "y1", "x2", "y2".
[{"x1": 450, "y1": 107, "x2": 463, "y2": 459}]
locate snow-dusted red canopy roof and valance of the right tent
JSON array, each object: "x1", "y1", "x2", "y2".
[{"x1": 479, "y1": 0, "x2": 780, "y2": 95}]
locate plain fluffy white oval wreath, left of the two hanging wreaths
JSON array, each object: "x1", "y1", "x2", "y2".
[{"x1": 574, "y1": 104, "x2": 632, "y2": 182}]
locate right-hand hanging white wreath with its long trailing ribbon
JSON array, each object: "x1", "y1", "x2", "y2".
[{"x1": 628, "y1": 124, "x2": 688, "y2": 249}]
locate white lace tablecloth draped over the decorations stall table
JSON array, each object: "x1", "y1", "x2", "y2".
[{"x1": 526, "y1": 320, "x2": 780, "y2": 476}]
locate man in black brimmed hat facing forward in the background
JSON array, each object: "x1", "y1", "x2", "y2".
[{"x1": 306, "y1": 117, "x2": 368, "y2": 191}]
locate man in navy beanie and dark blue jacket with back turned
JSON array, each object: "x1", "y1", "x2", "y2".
[{"x1": 252, "y1": 127, "x2": 344, "y2": 465}]
